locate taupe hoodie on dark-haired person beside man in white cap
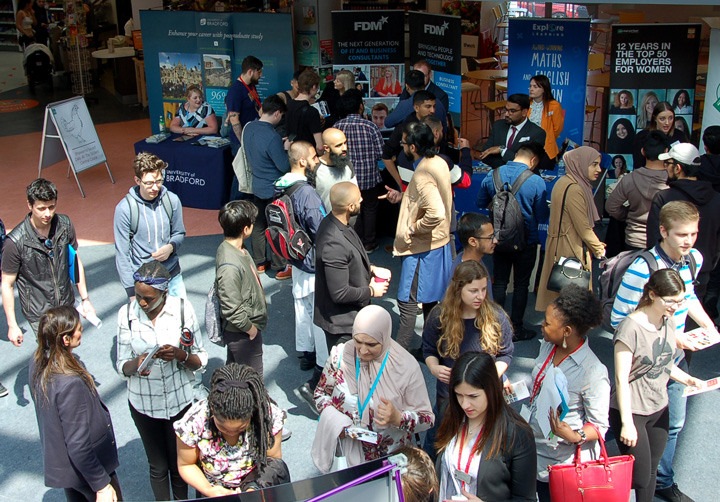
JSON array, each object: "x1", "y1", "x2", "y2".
[{"x1": 605, "y1": 167, "x2": 667, "y2": 248}]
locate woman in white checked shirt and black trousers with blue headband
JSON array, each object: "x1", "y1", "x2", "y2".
[{"x1": 116, "y1": 260, "x2": 208, "y2": 500}]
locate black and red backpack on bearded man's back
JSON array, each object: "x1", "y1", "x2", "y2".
[{"x1": 265, "y1": 181, "x2": 312, "y2": 261}]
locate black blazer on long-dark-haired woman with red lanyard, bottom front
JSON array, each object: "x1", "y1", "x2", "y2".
[{"x1": 435, "y1": 414, "x2": 537, "y2": 502}]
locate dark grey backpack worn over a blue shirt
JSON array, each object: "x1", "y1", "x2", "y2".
[{"x1": 489, "y1": 168, "x2": 533, "y2": 252}]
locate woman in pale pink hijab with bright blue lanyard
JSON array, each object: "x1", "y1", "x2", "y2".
[{"x1": 312, "y1": 305, "x2": 435, "y2": 473}]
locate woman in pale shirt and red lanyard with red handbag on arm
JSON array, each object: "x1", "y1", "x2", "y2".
[{"x1": 529, "y1": 284, "x2": 610, "y2": 502}]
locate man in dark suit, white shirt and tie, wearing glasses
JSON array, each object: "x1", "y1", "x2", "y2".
[{"x1": 480, "y1": 94, "x2": 547, "y2": 169}]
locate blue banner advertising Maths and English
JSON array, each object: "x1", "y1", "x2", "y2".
[{"x1": 508, "y1": 18, "x2": 590, "y2": 153}]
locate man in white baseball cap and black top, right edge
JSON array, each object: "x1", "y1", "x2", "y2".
[{"x1": 646, "y1": 143, "x2": 720, "y2": 302}]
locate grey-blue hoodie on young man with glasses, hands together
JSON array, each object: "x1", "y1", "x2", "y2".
[{"x1": 113, "y1": 186, "x2": 185, "y2": 297}]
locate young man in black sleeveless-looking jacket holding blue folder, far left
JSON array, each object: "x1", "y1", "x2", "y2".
[{"x1": 2, "y1": 178, "x2": 95, "y2": 347}]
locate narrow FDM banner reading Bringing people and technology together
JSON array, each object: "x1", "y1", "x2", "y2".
[{"x1": 410, "y1": 12, "x2": 462, "y2": 123}]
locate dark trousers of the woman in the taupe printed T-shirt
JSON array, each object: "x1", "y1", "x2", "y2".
[{"x1": 610, "y1": 406, "x2": 670, "y2": 502}]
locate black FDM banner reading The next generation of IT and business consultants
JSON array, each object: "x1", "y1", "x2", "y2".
[{"x1": 332, "y1": 10, "x2": 405, "y2": 130}]
